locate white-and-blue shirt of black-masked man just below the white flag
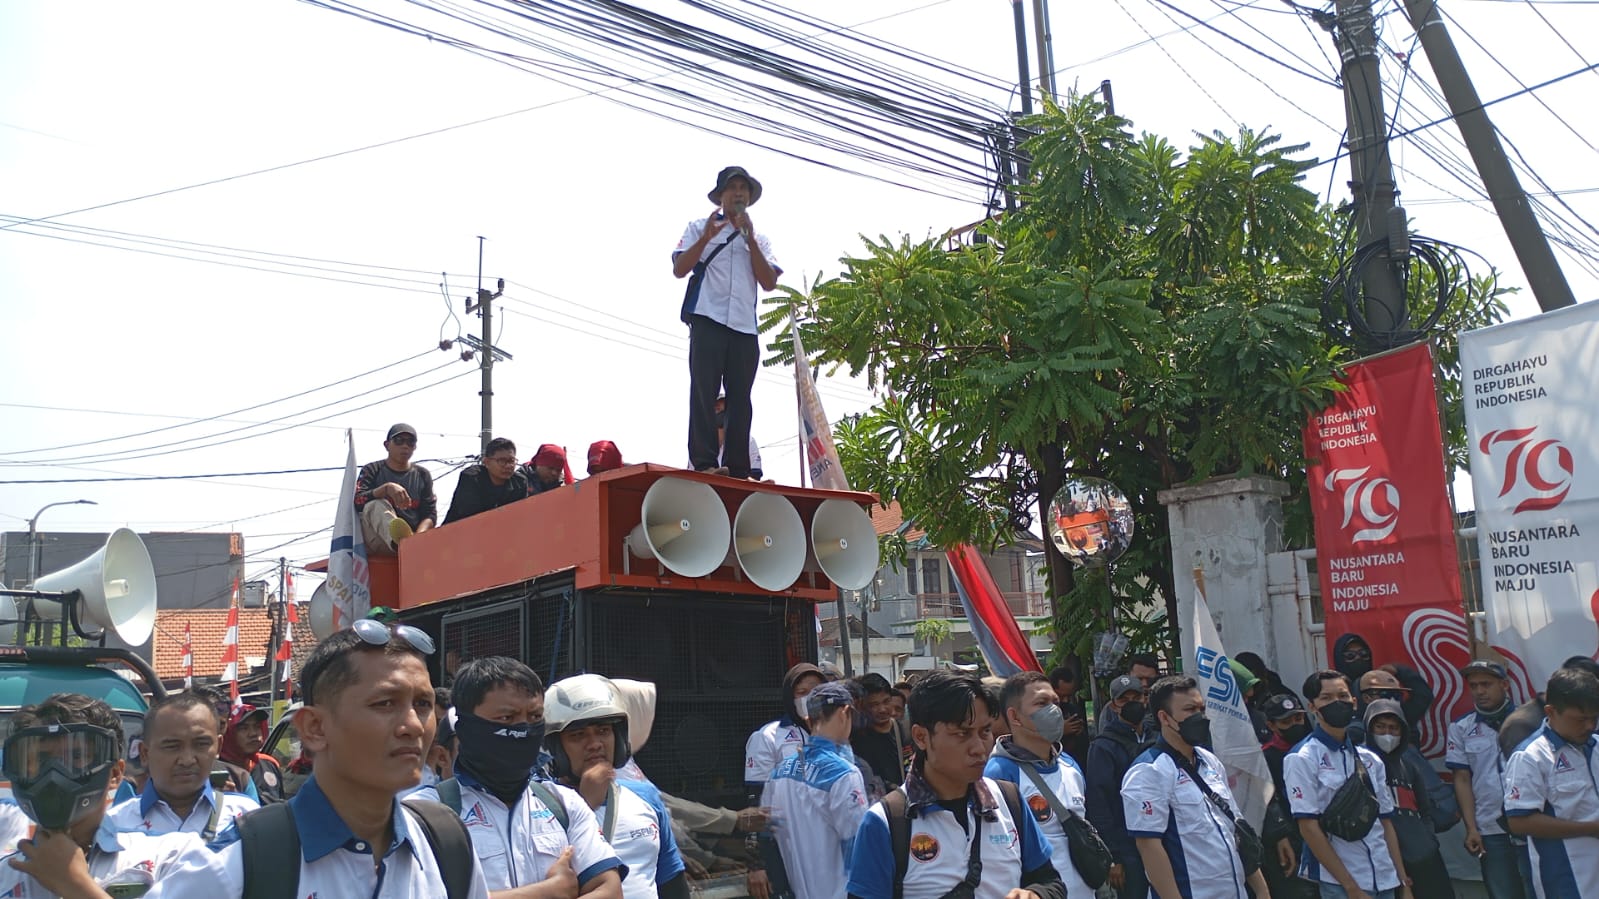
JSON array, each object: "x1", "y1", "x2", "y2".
[{"x1": 1119, "y1": 742, "x2": 1249, "y2": 899}]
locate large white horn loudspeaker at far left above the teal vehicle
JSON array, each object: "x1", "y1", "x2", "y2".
[{"x1": 32, "y1": 528, "x2": 155, "y2": 646}]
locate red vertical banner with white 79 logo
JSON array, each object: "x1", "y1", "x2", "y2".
[{"x1": 1305, "y1": 344, "x2": 1471, "y2": 755}]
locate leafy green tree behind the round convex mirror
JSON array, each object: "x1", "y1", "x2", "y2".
[{"x1": 763, "y1": 98, "x2": 1503, "y2": 654}]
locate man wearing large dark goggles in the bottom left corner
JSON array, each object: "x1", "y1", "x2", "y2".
[{"x1": 0, "y1": 693, "x2": 222, "y2": 899}]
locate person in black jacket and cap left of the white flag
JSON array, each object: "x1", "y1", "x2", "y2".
[{"x1": 1083, "y1": 675, "x2": 1150, "y2": 899}]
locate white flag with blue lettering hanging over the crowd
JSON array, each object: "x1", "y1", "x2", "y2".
[{"x1": 1190, "y1": 589, "x2": 1276, "y2": 825}]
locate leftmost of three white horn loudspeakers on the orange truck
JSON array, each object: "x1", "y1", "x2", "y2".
[{"x1": 627, "y1": 477, "x2": 732, "y2": 577}]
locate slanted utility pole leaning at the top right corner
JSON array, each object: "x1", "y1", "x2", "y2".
[{"x1": 1404, "y1": 0, "x2": 1577, "y2": 312}]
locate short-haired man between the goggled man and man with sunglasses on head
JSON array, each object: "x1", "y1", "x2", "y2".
[{"x1": 107, "y1": 693, "x2": 261, "y2": 841}]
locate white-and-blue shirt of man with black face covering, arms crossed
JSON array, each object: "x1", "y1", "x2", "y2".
[{"x1": 456, "y1": 771, "x2": 627, "y2": 889}]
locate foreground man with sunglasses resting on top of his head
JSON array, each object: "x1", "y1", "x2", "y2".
[{"x1": 161, "y1": 617, "x2": 488, "y2": 899}]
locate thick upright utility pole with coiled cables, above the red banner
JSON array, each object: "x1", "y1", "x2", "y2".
[{"x1": 1334, "y1": 0, "x2": 1409, "y2": 333}]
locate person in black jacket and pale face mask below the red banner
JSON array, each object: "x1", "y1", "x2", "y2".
[{"x1": 1366, "y1": 699, "x2": 1460, "y2": 899}]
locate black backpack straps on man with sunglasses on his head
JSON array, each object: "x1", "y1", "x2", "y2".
[{"x1": 233, "y1": 800, "x2": 477, "y2": 899}]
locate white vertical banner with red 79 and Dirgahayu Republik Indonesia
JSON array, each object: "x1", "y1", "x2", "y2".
[{"x1": 1460, "y1": 302, "x2": 1599, "y2": 684}]
